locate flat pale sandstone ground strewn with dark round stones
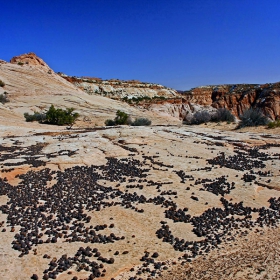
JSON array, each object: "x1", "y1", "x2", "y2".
[{"x1": 0, "y1": 126, "x2": 280, "y2": 279}]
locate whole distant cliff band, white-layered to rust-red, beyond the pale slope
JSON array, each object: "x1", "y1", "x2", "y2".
[{"x1": 60, "y1": 73, "x2": 280, "y2": 120}]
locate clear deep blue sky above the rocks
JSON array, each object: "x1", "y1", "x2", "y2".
[{"x1": 0, "y1": 0, "x2": 280, "y2": 90}]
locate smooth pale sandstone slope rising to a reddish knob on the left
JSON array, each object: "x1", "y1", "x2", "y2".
[{"x1": 0, "y1": 53, "x2": 179, "y2": 127}]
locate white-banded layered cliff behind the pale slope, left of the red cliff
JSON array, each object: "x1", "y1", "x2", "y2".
[{"x1": 58, "y1": 73, "x2": 180, "y2": 100}]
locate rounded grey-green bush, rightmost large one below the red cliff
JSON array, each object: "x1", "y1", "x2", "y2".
[{"x1": 237, "y1": 108, "x2": 269, "y2": 129}]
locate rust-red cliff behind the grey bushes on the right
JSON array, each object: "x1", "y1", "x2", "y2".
[{"x1": 140, "y1": 83, "x2": 280, "y2": 120}]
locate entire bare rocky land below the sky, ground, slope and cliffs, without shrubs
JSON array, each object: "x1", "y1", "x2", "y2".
[{"x1": 0, "y1": 53, "x2": 280, "y2": 280}]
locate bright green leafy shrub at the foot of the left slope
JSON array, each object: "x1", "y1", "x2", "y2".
[{"x1": 46, "y1": 105, "x2": 79, "y2": 125}]
